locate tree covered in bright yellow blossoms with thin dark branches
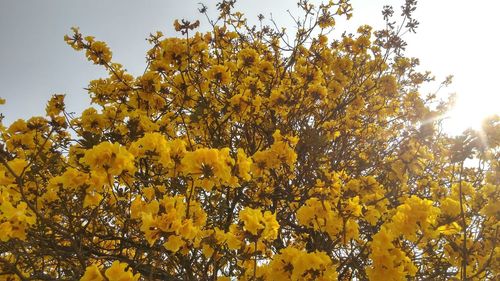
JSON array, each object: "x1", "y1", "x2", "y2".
[{"x1": 0, "y1": 0, "x2": 500, "y2": 280}]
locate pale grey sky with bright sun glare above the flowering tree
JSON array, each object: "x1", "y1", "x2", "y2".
[{"x1": 0, "y1": 0, "x2": 500, "y2": 133}]
